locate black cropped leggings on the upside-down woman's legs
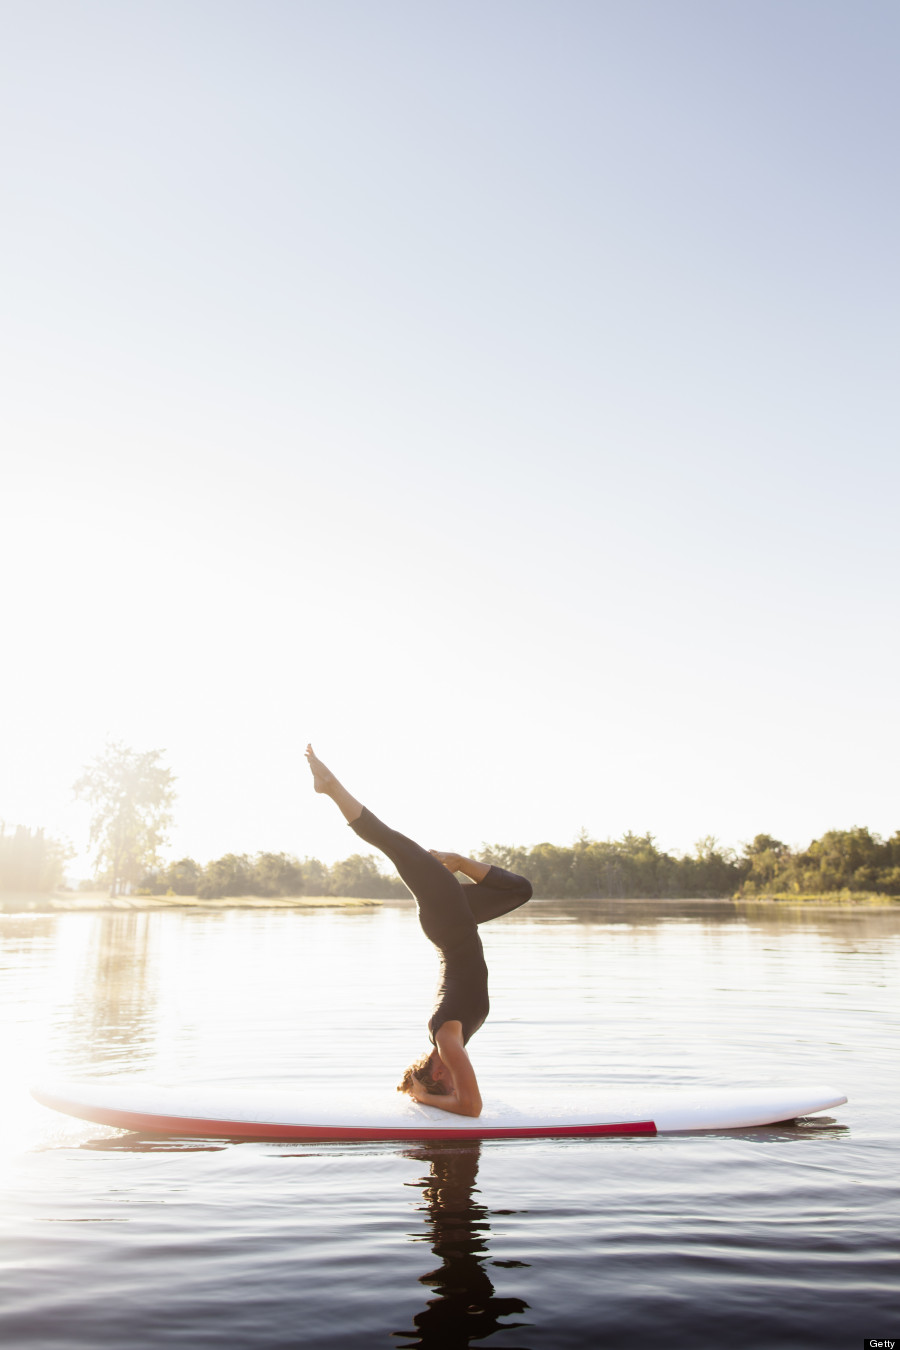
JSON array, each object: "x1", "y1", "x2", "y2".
[{"x1": 349, "y1": 807, "x2": 532, "y2": 950}]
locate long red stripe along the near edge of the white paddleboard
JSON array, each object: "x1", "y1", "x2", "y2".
[{"x1": 38, "y1": 1092, "x2": 656, "y2": 1142}]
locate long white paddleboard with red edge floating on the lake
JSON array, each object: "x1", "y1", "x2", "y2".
[{"x1": 31, "y1": 1079, "x2": 847, "y2": 1141}]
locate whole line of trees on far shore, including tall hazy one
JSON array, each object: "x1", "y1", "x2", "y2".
[{"x1": 0, "y1": 741, "x2": 900, "y2": 899}]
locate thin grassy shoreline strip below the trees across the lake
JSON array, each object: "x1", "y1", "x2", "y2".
[{"x1": 0, "y1": 891, "x2": 900, "y2": 914}]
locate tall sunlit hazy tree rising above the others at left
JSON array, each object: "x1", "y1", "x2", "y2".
[{"x1": 74, "y1": 741, "x2": 175, "y2": 895}]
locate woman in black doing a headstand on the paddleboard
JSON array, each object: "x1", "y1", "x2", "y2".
[{"x1": 306, "y1": 745, "x2": 532, "y2": 1115}]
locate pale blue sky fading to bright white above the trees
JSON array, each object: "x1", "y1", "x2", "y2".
[{"x1": 0, "y1": 0, "x2": 900, "y2": 875}]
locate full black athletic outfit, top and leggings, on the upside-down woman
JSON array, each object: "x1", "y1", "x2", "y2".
[{"x1": 349, "y1": 807, "x2": 532, "y2": 1044}]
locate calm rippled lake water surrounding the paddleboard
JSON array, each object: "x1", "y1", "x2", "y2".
[{"x1": 0, "y1": 902, "x2": 900, "y2": 1350}]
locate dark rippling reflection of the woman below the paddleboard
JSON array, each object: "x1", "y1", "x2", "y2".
[{"x1": 394, "y1": 1141, "x2": 528, "y2": 1350}]
